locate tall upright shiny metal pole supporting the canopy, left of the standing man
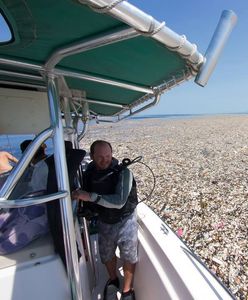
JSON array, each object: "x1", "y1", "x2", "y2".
[{"x1": 47, "y1": 75, "x2": 83, "y2": 300}]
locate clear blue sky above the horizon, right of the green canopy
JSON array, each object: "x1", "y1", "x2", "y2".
[{"x1": 132, "y1": 0, "x2": 248, "y2": 114}]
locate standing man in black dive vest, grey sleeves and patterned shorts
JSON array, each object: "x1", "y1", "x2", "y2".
[{"x1": 73, "y1": 140, "x2": 138, "y2": 300}]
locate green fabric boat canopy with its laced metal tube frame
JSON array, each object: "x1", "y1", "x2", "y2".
[{"x1": 0, "y1": 0, "x2": 237, "y2": 116}]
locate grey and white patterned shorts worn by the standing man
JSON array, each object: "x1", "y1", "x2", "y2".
[{"x1": 98, "y1": 212, "x2": 138, "y2": 264}]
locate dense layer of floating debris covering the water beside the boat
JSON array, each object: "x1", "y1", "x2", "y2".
[{"x1": 82, "y1": 116, "x2": 248, "y2": 300}]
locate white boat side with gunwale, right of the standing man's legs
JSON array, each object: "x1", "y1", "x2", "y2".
[{"x1": 134, "y1": 203, "x2": 233, "y2": 300}]
